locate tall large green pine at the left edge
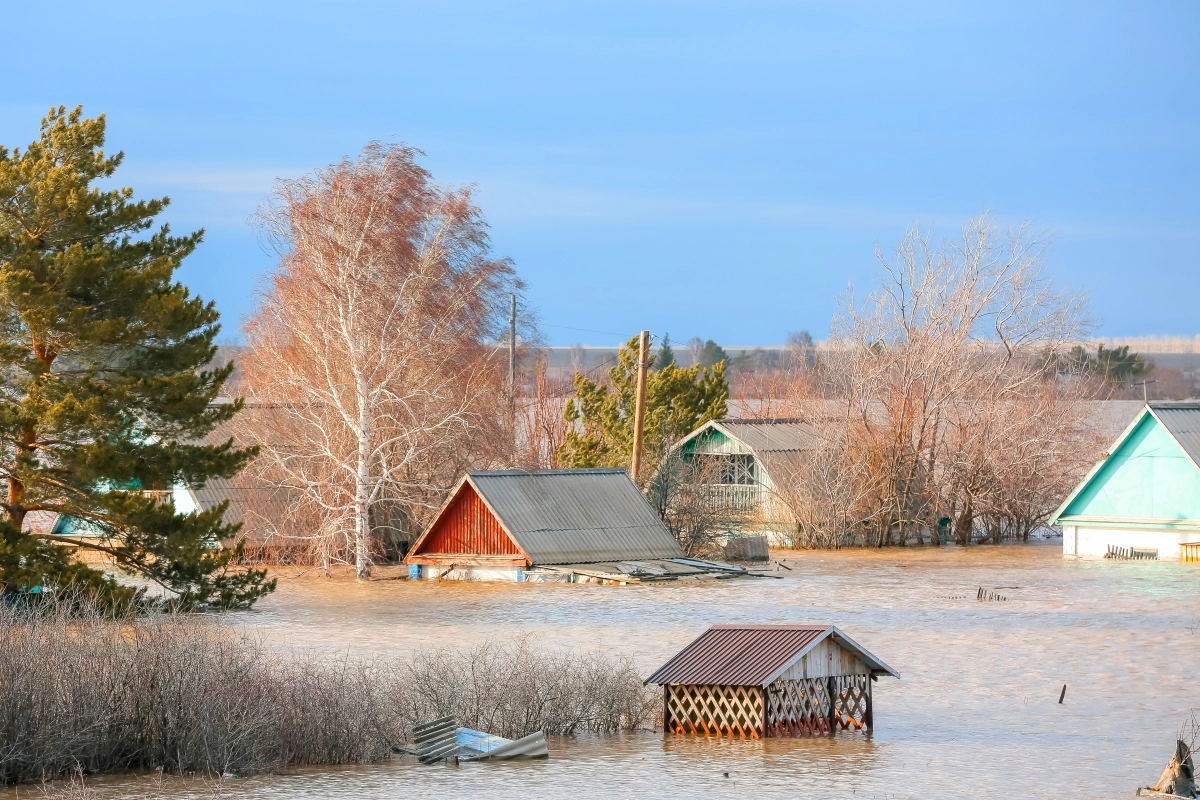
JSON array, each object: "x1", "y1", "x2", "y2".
[{"x1": 0, "y1": 107, "x2": 275, "y2": 608}]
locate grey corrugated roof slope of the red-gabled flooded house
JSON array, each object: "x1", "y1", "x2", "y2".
[{"x1": 469, "y1": 469, "x2": 683, "y2": 564}]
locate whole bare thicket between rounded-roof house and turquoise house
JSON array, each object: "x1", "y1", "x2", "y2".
[{"x1": 746, "y1": 217, "x2": 1094, "y2": 547}]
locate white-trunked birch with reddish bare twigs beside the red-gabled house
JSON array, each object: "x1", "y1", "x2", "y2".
[{"x1": 242, "y1": 143, "x2": 521, "y2": 576}]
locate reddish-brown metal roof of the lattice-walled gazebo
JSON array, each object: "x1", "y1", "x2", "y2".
[{"x1": 646, "y1": 625, "x2": 900, "y2": 686}]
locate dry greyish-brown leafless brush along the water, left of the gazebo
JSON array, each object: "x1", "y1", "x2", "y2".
[{"x1": 0, "y1": 604, "x2": 656, "y2": 783}]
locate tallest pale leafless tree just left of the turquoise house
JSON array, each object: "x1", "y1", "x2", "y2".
[{"x1": 827, "y1": 216, "x2": 1099, "y2": 543}]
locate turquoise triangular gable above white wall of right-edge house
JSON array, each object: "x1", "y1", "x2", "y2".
[{"x1": 1050, "y1": 403, "x2": 1200, "y2": 524}]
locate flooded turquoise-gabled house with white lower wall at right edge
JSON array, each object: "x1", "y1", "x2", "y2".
[{"x1": 1050, "y1": 403, "x2": 1200, "y2": 559}]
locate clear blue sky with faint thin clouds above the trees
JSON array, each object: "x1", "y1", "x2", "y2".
[{"x1": 0, "y1": 0, "x2": 1200, "y2": 344}]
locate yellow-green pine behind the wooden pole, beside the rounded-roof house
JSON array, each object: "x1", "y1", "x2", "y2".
[{"x1": 558, "y1": 336, "x2": 730, "y2": 475}]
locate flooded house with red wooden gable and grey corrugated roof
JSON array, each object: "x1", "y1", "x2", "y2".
[{"x1": 404, "y1": 469, "x2": 745, "y2": 584}]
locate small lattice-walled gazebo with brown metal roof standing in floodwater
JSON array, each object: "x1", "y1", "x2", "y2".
[{"x1": 646, "y1": 625, "x2": 900, "y2": 739}]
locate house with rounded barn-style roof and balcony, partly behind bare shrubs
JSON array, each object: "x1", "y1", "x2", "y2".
[{"x1": 677, "y1": 419, "x2": 817, "y2": 545}]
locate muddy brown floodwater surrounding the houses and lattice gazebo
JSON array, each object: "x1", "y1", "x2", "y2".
[{"x1": 23, "y1": 545, "x2": 1200, "y2": 800}]
